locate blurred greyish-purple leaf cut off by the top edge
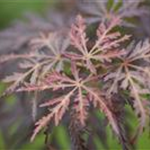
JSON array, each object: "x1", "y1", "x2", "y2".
[{"x1": 78, "y1": 0, "x2": 148, "y2": 26}]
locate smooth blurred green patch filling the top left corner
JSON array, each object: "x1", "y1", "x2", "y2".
[{"x1": 0, "y1": 0, "x2": 58, "y2": 28}]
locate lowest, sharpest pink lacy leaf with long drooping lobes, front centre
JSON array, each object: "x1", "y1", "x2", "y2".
[{"x1": 17, "y1": 63, "x2": 120, "y2": 142}]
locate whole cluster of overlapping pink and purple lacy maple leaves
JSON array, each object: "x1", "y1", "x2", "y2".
[{"x1": 0, "y1": 0, "x2": 150, "y2": 150}]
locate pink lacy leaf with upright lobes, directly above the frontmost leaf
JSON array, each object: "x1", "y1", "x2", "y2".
[{"x1": 67, "y1": 15, "x2": 130, "y2": 74}]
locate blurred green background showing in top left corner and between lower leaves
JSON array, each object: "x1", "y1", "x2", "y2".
[{"x1": 0, "y1": 0, "x2": 150, "y2": 150}]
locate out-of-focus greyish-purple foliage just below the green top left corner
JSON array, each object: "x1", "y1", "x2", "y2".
[{"x1": 0, "y1": 9, "x2": 73, "y2": 54}]
